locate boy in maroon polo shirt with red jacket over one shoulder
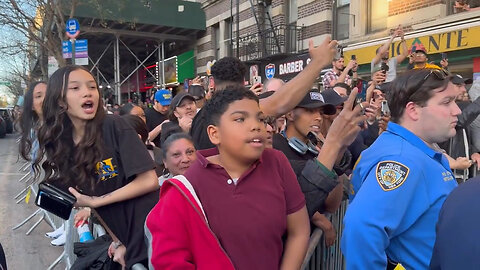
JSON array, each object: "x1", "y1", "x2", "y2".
[{"x1": 147, "y1": 86, "x2": 310, "y2": 270}]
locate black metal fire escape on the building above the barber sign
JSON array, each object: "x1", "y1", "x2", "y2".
[{"x1": 232, "y1": 0, "x2": 304, "y2": 61}]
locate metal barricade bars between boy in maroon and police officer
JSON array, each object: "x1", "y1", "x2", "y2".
[{"x1": 301, "y1": 200, "x2": 348, "y2": 270}]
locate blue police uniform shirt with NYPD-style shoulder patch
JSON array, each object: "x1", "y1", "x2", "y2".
[{"x1": 341, "y1": 122, "x2": 457, "y2": 269}]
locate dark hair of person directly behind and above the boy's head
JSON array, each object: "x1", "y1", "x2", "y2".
[{"x1": 212, "y1": 56, "x2": 247, "y2": 85}]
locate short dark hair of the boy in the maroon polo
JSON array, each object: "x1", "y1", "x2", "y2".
[{"x1": 202, "y1": 85, "x2": 258, "y2": 126}]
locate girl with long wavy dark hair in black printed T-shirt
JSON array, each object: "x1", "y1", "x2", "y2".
[{"x1": 35, "y1": 66, "x2": 158, "y2": 268}]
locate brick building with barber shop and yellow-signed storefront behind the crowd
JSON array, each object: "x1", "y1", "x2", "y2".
[{"x1": 196, "y1": 0, "x2": 480, "y2": 80}]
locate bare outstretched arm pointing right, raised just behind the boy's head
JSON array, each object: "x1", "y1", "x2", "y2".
[{"x1": 260, "y1": 37, "x2": 337, "y2": 117}]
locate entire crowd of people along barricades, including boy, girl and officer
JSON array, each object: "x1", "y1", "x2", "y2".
[{"x1": 13, "y1": 27, "x2": 480, "y2": 269}]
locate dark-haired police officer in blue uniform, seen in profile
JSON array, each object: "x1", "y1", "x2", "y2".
[{"x1": 342, "y1": 69, "x2": 461, "y2": 269}]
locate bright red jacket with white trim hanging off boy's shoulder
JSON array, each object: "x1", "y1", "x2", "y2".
[{"x1": 145, "y1": 175, "x2": 234, "y2": 270}]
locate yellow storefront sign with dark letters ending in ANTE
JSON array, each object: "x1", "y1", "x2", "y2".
[{"x1": 344, "y1": 26, "x2": 480, "y2": 64}]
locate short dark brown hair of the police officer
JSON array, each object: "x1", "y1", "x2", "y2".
[{"x1": 386, "y1": 69, "x2": 450, "y2": 123}]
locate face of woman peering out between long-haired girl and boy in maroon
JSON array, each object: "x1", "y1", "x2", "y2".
[{"x1": 159, "y1": 133, "x2": 197, "y2": 186}]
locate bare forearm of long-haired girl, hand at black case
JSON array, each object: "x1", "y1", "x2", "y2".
[{"x1": 68, "y1": 170, "x2": 159, "y2": 208}]
